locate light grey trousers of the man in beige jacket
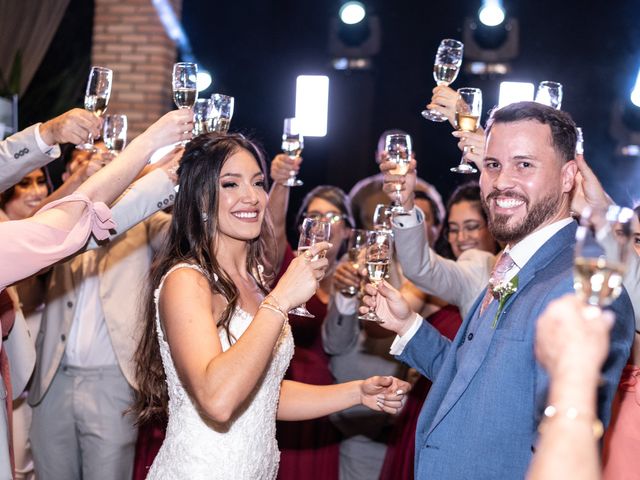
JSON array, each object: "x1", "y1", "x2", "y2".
[{"x1": 31, "y1": 365, "x2": 137, "y2": 480}]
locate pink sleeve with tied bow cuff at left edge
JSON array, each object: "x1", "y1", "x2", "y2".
[{"x1": 0, "y1": 193, "x2": 116, "y2": 290}]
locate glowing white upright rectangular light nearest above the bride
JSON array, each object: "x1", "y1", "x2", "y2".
[{"x1": 296, "y1": 75, "x2": 329, "y2": 137}]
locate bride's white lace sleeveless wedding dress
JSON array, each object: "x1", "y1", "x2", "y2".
[{"x1": 147, "y1": 264, "x2": 293, "y2": 480}]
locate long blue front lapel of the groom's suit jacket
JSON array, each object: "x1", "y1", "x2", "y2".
[{"x1": 427, "y1": 222, "x2": 576, "y2": 435}]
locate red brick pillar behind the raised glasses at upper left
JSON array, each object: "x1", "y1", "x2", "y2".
[{"x1": 91, "y1": 0, "x2": 182, "y2": 139}]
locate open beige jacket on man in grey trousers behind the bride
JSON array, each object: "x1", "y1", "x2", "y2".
[{"x1": 28, "y1": 172, "x2": 174, "y2": 405}]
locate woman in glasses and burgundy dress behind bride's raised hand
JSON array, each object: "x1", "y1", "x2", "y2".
[{"x1": 269, "y1": 154, "x2": 354, "y2": 480}]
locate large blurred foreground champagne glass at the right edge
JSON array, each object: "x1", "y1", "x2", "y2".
[{"x1": 573, "y1": 205, "x2": 634, "y2": 308}]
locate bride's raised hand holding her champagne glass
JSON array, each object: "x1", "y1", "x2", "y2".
[{"x1": 271, "y1": 242, "x2": 331, "y2": 310}]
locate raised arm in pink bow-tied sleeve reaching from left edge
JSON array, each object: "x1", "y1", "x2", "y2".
[{"x1": 0, "y1": 110, "x2": 193, "y2": 290}]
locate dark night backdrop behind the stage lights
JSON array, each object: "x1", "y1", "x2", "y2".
[{"x1": 20, "y1": 0, "x2": 640, "y2": 217}]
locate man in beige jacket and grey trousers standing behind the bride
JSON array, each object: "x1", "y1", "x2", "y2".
[{"x1": 28, "y1": 163, "x2": 174, "y2": 480}]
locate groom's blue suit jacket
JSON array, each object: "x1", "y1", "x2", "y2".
[{"x1": 398, "y1": 223, "x2": 634, "y2": 480}]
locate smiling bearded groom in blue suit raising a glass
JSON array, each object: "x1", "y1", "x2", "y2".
[{"x1": 365, "y1": 102, "x2": 634, "y2": 479}]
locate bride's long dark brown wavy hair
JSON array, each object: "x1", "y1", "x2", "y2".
[{"x1": 132, "y1": 133, "x2": 275, "y2": 423}]
